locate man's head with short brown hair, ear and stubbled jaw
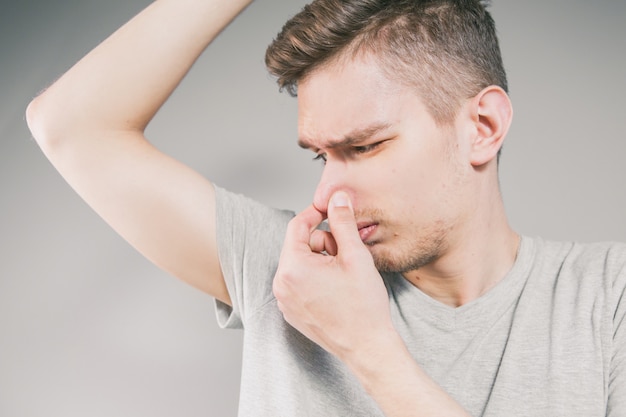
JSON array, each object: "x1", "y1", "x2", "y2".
[{"x1": 267, "y1": 0, "x2": 511, "y2": 272}]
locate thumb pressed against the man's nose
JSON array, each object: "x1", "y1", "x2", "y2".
[{"x1": 328, "y1": 191, "x2": 363, "y2": 256}]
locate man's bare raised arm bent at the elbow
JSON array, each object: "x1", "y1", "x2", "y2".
[{"x1": 27, "y1": 0, "x2": 251, "y2": 304}]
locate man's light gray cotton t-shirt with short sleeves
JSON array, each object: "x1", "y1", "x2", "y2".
[{"x1": 212, "y1": 188, "x2": 626, "y2": 417}]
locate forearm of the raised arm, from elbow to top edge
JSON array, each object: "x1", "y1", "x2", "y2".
[{"x1": 28, "y1": 0, "x2": 251, "y2": 145}]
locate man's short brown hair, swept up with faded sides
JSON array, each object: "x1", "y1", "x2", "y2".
[{"x1": 265, "y1": 0, "x2": 508, "y2": 123}]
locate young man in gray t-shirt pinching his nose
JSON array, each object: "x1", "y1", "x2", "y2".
[{"x1": 28, "y1": 0, "x2": 626, "y2": 416}]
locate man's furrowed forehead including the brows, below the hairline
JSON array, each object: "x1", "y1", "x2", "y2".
[{"x1": 297, "y1": 59, "x2": 426, "y2": 150}]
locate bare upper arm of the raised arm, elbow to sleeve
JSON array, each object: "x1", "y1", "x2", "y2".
[{"x1": 34, "y1": 126, "x2": 230, "y2": 304}]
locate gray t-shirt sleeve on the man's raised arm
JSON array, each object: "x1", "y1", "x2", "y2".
[{"x1": 215, "y1": 186, "x2": 294, "y2": 328}]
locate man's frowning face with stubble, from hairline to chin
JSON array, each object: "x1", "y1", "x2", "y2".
[{"x1": 298, "y1": 60, "x2": 470, "y2": 272}]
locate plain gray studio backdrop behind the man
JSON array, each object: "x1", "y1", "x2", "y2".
[{"x1": 0, "y1": 0, "x2": 626, "y2": 417}]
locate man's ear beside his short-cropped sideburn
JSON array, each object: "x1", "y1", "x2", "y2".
[{"x1": 469, "y1": 85, "x2": 513, "y2": 167}]
